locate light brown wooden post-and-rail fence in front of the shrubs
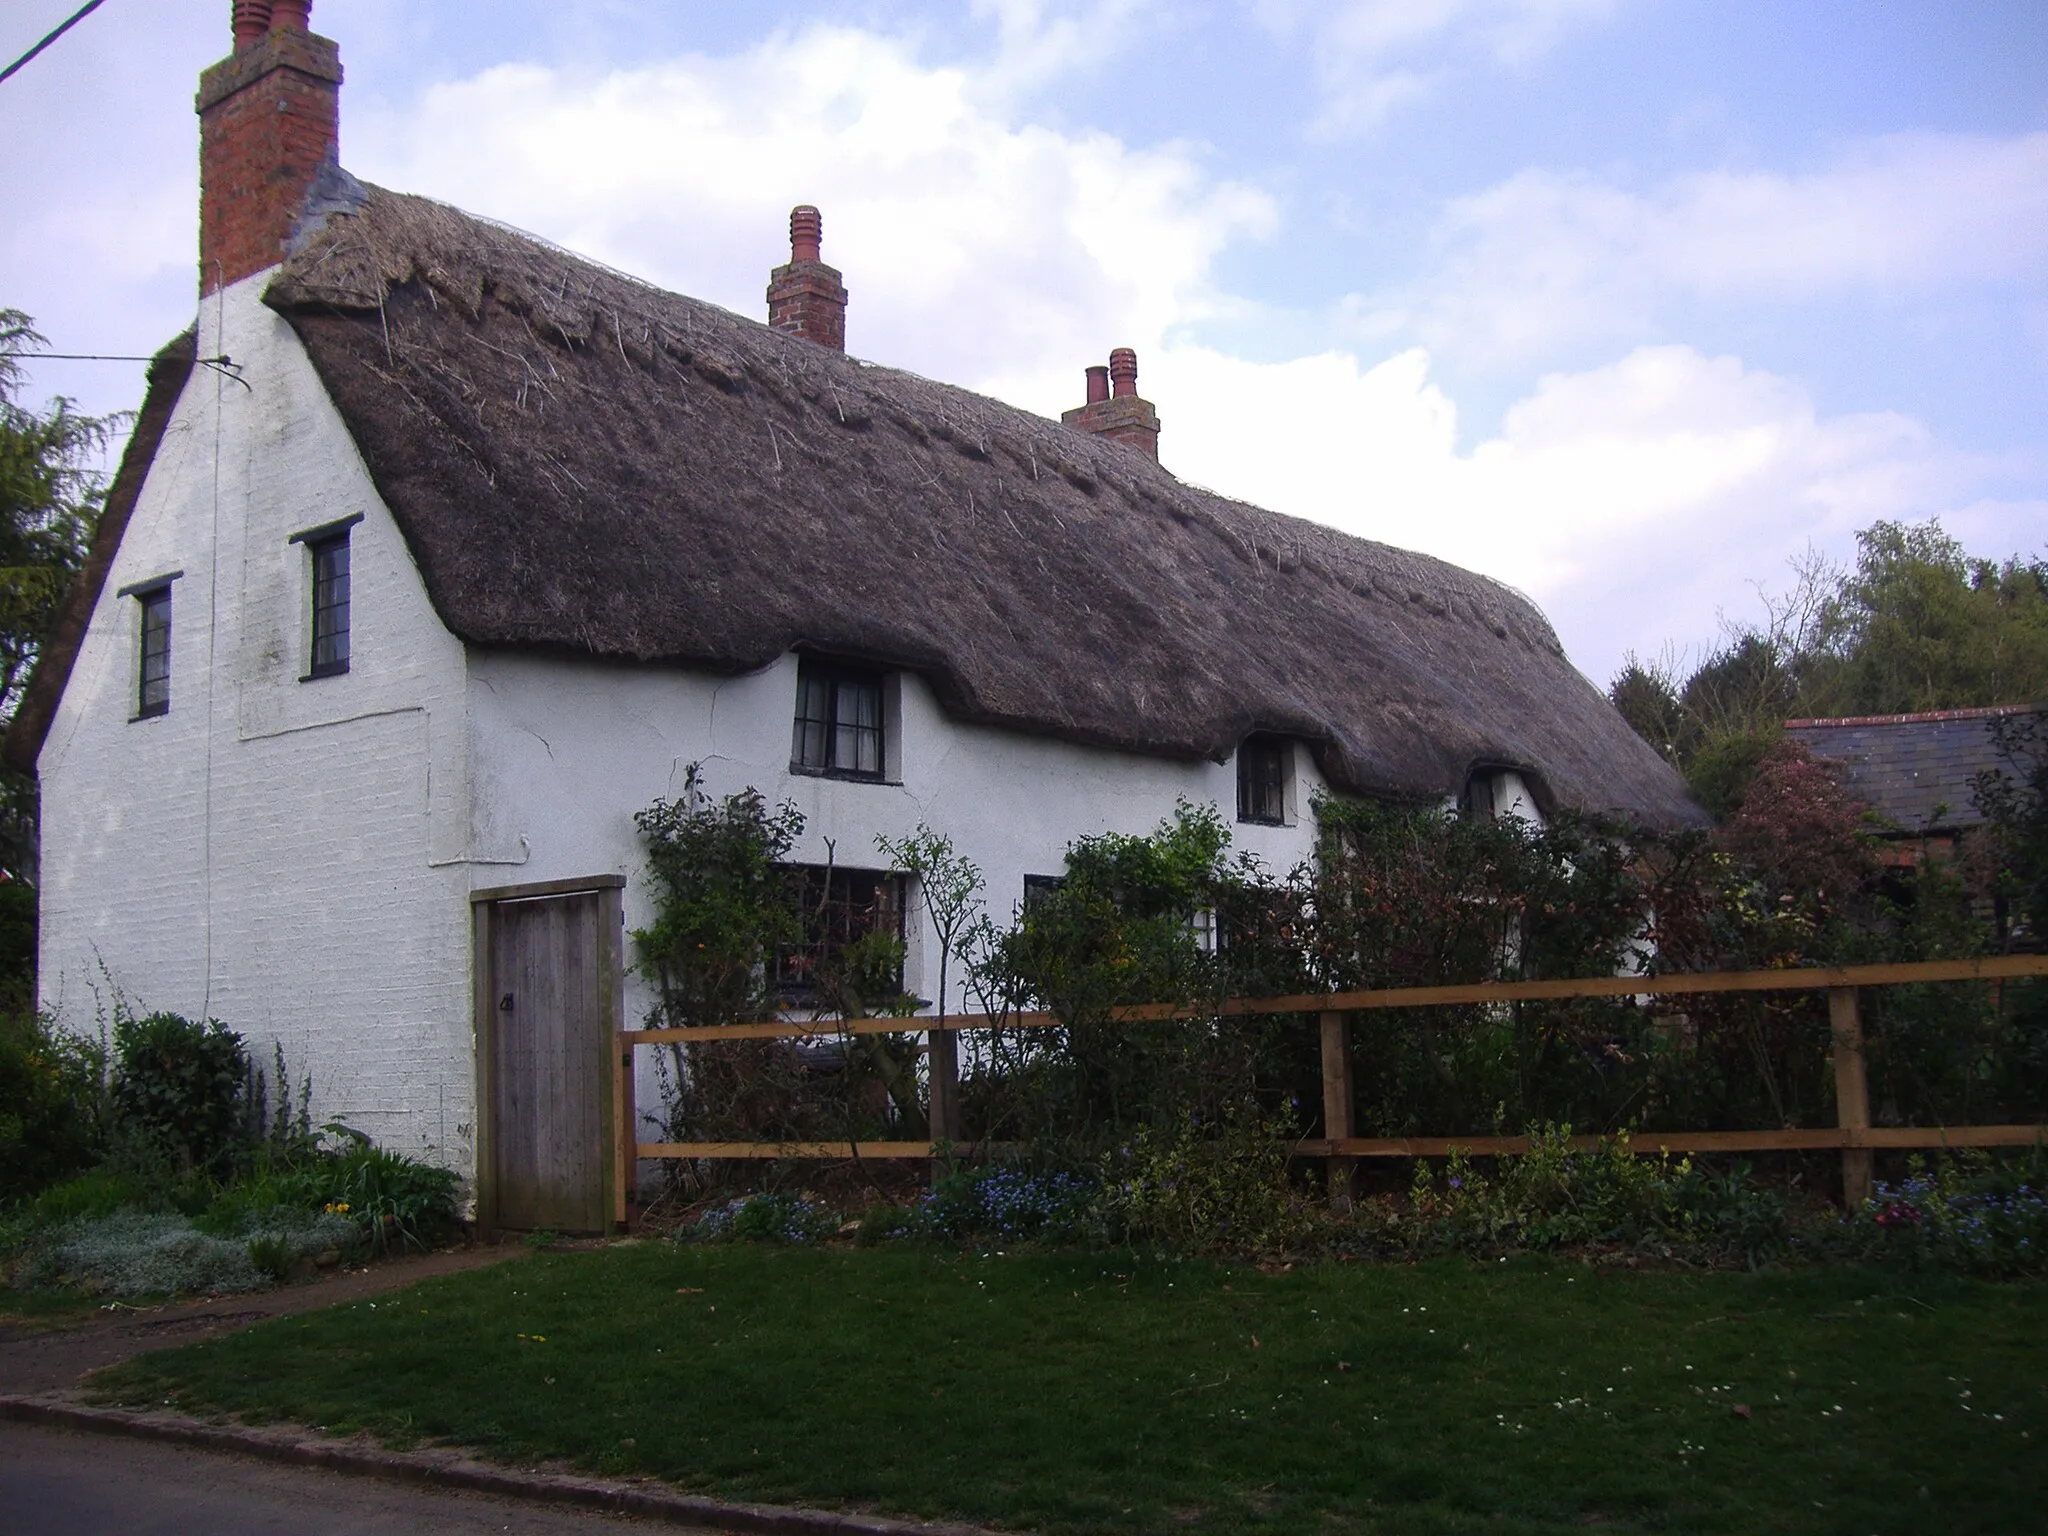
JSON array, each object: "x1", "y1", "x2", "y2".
[{"x1": 612, "y1": 954, "x2": 2048, "y2": 1223}]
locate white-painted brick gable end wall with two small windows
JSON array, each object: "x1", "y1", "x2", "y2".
[{"x1": 39, "y1": 276, "x2": 475, "y2": 1176}]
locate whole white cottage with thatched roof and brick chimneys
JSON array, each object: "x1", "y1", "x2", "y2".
[{"x1": 6, "y1": 0, "x2": 1698, "y2": 1227}]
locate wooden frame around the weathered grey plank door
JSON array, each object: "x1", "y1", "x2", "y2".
[{"x1": 469, "y1": 874, "x2": 627, "y2": 1237}]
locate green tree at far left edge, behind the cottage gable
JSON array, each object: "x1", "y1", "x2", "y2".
[{"x1": 0, "y1": 309, "x2": 127, "y2": 874}]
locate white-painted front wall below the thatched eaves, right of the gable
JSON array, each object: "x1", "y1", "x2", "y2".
[{"x1": 469, "y1": 651, "x2": 1323, "y2": 1146}]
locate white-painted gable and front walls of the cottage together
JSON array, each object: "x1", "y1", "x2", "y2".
[{"x1": 41, "y1": 276, "x2": 1351, "y2": 1176}]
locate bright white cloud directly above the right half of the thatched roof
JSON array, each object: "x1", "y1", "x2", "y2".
[{"x1": 1147, "y1": 346, "x2": 2023, "y2": 680}]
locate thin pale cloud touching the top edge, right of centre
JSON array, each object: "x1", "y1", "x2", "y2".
[{"x1": 1249, "y1": 0, "x2": 1620, "y2": 135}]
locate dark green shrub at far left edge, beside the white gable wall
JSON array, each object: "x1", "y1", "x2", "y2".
[{"x1": 0, "y1": 1011, "x2": 104, "y2": 1198}]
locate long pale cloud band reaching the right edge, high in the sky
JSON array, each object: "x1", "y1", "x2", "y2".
[{"x1": 1392, "y1": 133, "x2": 2048, "y2": 362}]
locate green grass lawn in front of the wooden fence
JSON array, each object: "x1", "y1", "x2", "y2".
[{"x1": 102, "y1": 1243, "x2": 2048, "y2": 1536}]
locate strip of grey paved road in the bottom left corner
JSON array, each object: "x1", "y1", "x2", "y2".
[{"x1": 0, "y1": 1419, "x2": 696, "y2": 1536}]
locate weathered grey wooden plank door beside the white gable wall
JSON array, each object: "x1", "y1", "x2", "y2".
[{"x1": 475, "y1": 887, "x2": 618, "y2": 1233}]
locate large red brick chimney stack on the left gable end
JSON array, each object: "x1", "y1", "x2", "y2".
[{"x1": 197, "y1": 0, "x2": 342, "y2": 295}]
